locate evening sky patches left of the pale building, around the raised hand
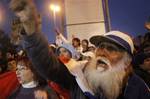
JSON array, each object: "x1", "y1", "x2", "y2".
[{"x1": 0, "y1": 0, "x2": 61, "y2": 42}]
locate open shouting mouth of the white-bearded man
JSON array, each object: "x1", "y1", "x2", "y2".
[{"x1": 96, "y1": 59, "x2": 109, "y2": 72}]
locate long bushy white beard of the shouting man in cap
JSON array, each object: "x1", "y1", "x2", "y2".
[{"x1": 84, "y1": 57, "x2": 126, "y2": 99}]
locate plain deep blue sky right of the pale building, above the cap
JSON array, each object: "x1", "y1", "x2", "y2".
[{"x1": 108, "y1": 0, "x2": 150, "y2": 37}]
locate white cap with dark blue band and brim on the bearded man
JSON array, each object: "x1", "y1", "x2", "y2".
[{"x1": 90, "y1": 31, "x2": 134, "y2": 55}]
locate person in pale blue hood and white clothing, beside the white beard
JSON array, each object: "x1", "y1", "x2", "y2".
[{"x1": 57, "y1": 44, "x2": 92, "y2": 93}]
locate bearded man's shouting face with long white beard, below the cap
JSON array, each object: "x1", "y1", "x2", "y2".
[{"x1": 84, "y1": 42, "x2": 128, "y2": 99}]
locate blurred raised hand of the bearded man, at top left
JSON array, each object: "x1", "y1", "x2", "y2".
[{"x1": 10, "y1": 0, "x2": 40, "y2": 35}]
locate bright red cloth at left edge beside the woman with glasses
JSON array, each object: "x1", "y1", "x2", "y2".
[{"x1": 0, "y1": 72, "x2": 19, "y2": 99}]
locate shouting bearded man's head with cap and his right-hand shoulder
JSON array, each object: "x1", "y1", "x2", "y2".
[{"x1": 84, "y1": 31, "x2": 150, "y2": 99}]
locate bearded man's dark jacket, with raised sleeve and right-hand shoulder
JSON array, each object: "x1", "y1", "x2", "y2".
[{"x1": 24, "y1": 33, "x2": 150, "y2": 99}]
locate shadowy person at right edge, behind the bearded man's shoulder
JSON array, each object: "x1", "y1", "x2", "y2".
[{"x1": 134, "y1": 40, "x2": 150, "y2": 88}]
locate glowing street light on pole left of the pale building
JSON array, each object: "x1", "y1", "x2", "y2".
[{"x1": 49, "y1": 4, "x2": 60, "y2": 28}]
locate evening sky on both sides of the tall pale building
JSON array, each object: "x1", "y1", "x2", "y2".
[{"x1": 0, "y1": 0, "x2": 150, "y2": 42}]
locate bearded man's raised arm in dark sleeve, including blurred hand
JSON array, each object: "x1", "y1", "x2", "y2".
[{"x1": 11, "y1": 0, "x2": 74, "y2": 89}]
